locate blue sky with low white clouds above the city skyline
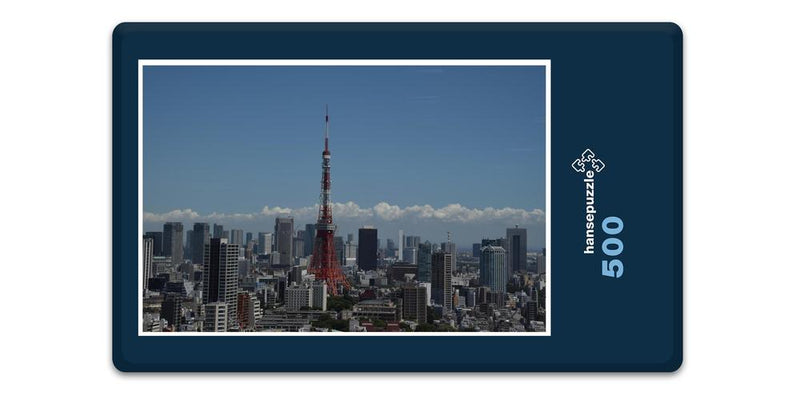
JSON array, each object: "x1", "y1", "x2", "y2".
[{"x1": 144, "y1": 66, "x2": 545, "y2": 247}]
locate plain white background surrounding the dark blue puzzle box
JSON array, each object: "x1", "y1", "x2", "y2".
[{"x1": 0, "y1": 0, "x2": 800, "y2": 399}]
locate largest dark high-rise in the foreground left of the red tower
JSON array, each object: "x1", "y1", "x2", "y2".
[{"x1": 203, "y1": 238, "x2": 239, "y2": 329}]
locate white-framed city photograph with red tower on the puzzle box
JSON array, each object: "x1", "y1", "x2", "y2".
[{"x1": 138, "y1": 60, "x2": 550, "y2": 335}]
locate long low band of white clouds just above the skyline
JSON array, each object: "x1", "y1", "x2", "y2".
[{"x1": 144, "y1": 201, "x2": 544, "y2": 223}]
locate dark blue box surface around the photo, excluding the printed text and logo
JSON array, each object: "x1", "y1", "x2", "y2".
[{"x1": 112, "y1": 23, "x2": 683, "y2": 372}]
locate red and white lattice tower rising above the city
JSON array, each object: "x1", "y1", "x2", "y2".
[{"x1": 308, "y1": 105, "x2": 350, "y2": 295}]
